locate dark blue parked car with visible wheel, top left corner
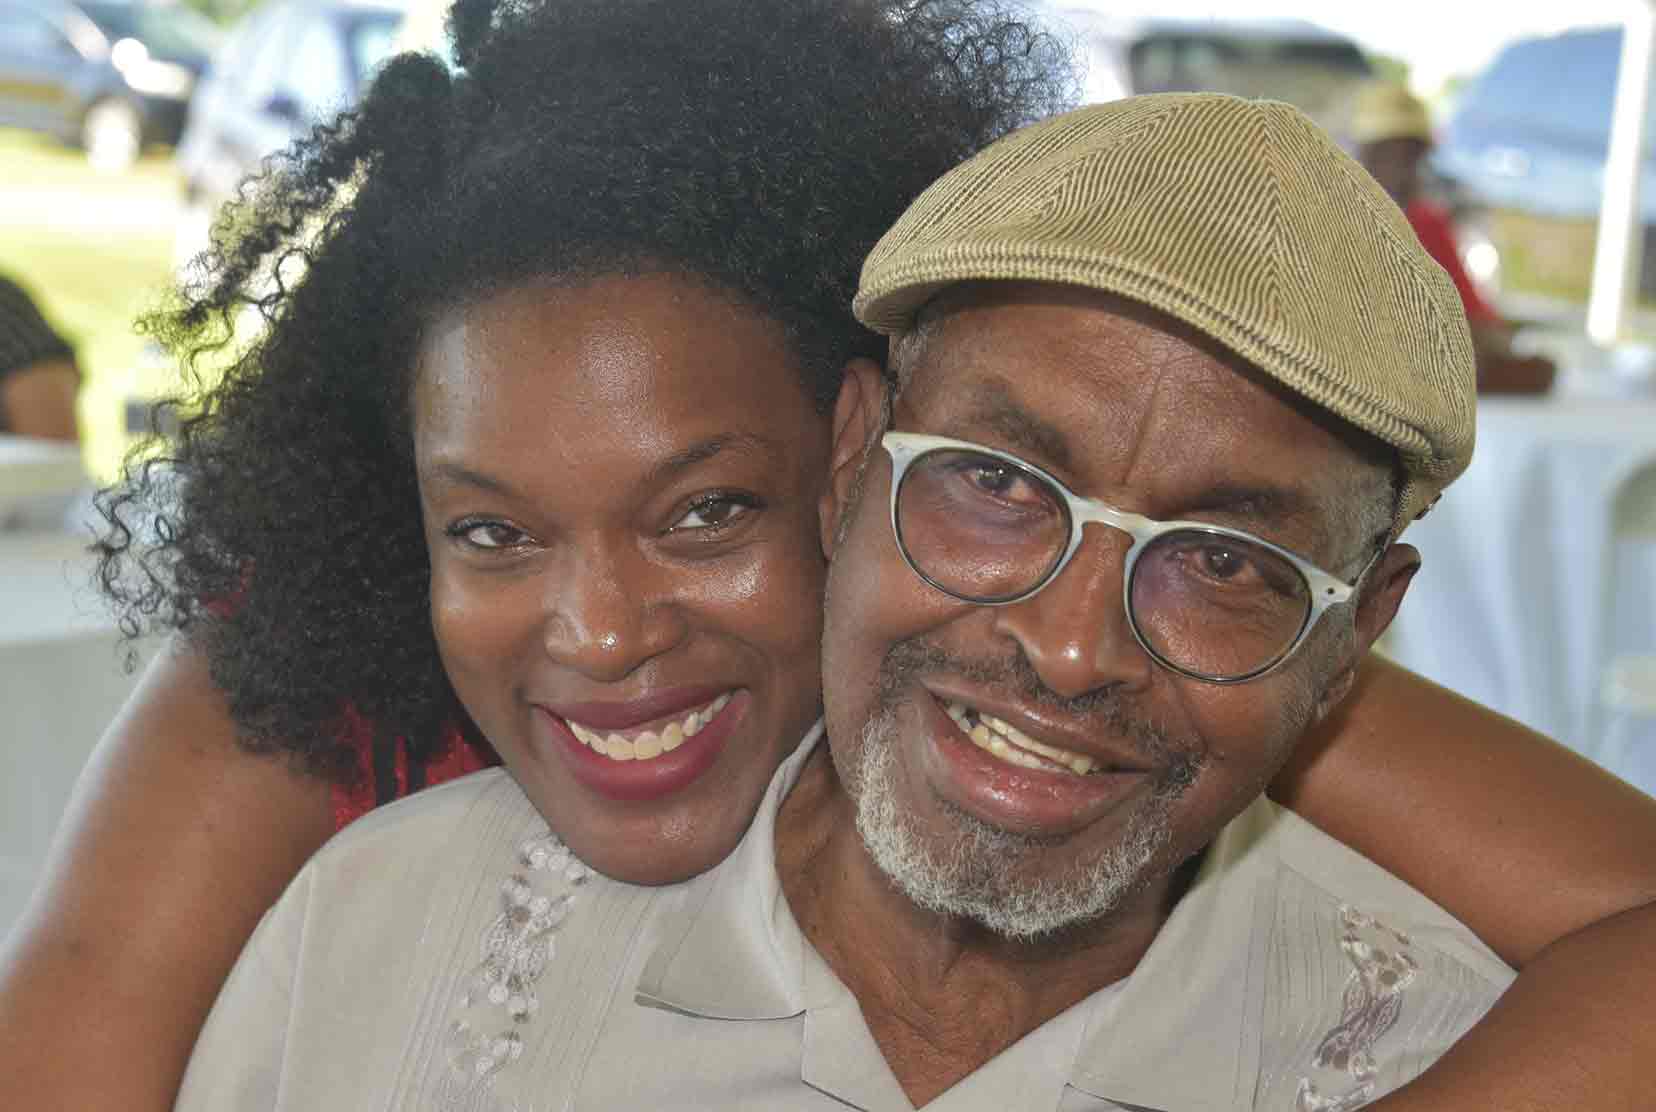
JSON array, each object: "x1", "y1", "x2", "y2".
[{"x1": 0, "y1": 0, "x2": 219, "y2": 169}]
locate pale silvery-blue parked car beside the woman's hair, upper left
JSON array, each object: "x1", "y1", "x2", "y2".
[{"x1": 177, "y1": 0, "x2": 404, "y2": 210}]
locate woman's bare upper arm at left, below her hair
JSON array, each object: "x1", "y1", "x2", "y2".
[{"x1": 0, "y1": 641, "x2": 333, "y2": 1112}]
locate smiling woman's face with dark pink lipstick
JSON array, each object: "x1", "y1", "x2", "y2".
[{"x1": 414, "y1": 273, "x2": 828, "y2": 882}]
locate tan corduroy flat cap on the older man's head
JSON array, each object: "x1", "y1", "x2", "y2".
[{"x1": 854, "y1": 93, "x2": 1475, "y2": 534}]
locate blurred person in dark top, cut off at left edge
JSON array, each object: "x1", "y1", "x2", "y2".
[{"x1": 0, "y1": 275, "x2": 81, "y2": 441}]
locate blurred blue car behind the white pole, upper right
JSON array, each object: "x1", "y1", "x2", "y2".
[{"x1": 1432, "y1": 27, "x2": 1656, "y2": 293}]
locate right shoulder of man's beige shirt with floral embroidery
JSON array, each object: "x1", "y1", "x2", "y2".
[{"x1": 1085, "y1": 799, "x2": 1512, "y2": 1109}]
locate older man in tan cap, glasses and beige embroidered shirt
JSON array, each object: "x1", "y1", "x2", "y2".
[{"x1": 181, "y1": 96, "x2": 1510, "y2": 1112}]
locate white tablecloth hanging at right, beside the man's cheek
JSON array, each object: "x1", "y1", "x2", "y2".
[{"x1": 1386, "y1": 382, "x2": 1656, "y2": 756}]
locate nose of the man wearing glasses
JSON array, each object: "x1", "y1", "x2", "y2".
[{"x1": 995, "y1": 525, "x2": 1156, "y2": 698}]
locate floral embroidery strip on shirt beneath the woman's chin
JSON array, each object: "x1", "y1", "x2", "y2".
[{"x1": 444, "y1": 834, "x2": 593, "y2": 1105}]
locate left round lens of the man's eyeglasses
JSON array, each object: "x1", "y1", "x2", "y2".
[{"x1": 898, "y1": 449, "x2": 1070, "y2": 603}]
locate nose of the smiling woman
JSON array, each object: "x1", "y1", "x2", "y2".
[{"x1": 543, "y1": 550, "x2": 687, "y2": 683}]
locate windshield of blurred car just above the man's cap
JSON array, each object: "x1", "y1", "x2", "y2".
[{"x1": 1128, "y1": 31, "x2": 1370, "y2": 121}]
